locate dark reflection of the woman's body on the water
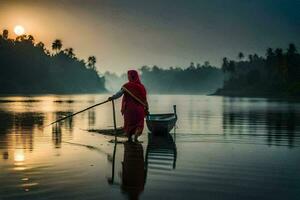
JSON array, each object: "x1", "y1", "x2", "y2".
[{"x1": 122, "y1": 142, "x2": 146, "y2": 199}]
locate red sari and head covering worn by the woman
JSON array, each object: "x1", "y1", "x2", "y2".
[{"x1": 121, "y1": 70, "x2": 147, "y2": 135}]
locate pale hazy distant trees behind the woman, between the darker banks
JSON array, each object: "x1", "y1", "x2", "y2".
[{"x1": 105, "y1": 62, "x2": 223, "y2": 94}]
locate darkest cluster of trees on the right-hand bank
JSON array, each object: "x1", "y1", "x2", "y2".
[{"x1": 216, "y1": 44, "x2": 300, "y2": 97}]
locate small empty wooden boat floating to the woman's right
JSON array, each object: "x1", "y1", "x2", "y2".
[{"x1": 146, "y1": 105, "x2": 177, "y2": 134}]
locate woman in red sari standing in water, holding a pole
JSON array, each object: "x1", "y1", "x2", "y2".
[{"x1": 108, "y1": 70, "x2": 148, "y2": 142}]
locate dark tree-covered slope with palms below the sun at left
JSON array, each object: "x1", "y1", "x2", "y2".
[{"x1": 0, "y1": 30, "x2": 105, "y2": 94}]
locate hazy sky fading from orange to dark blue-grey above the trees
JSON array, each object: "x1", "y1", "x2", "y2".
[{"x1": 0, "y1": 0, "x2": 300, "y2": 73}]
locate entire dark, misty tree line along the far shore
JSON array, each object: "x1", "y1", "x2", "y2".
[{"x1": 0, "y1": 27, "x2": 300, "y2": 97}]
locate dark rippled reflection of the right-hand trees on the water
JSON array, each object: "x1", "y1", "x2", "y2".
[{"x1": 223, "y1": 98, "x2": 300, "y2": 147}]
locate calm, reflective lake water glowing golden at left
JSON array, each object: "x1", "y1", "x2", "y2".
[{"x1": 0, "y1": 95, "x2": 300, "y2": 200}]
